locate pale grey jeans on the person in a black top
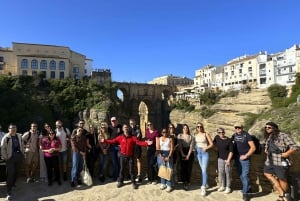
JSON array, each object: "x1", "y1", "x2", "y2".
[{"x1": 218, "y1": 158, "x2": 232, "y2": 188}]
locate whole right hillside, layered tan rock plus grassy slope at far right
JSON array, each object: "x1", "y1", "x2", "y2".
[{"x1": 170, "y1": 89, "x2": 300, "y2": 144}]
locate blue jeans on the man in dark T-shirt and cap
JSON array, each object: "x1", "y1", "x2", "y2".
[{"x1": 235, "y1": 156, "x2": 250, "y2": 194}]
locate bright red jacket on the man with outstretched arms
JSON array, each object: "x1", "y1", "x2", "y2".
[{"x1": 104, "y1": 134, "x2": 148, "y2": 156}]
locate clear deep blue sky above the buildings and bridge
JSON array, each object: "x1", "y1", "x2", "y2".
[{"x1": 0, "y1": 0, "x2": 300, "y2": 83}]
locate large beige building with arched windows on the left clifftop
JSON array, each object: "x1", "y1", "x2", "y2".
[{"x1": 0, "y1": 42, "x2": 86, "y2": 79}]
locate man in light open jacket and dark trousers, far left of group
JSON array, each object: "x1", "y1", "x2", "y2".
[{"x1": 1, "y1": 123, "x2": 24, "y2": 200}]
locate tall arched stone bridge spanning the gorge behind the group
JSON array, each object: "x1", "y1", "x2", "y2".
[{"x1": 114, "y1": 82, "x2": 176, "y2": 134}]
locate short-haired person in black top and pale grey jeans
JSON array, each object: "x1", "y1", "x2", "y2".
[{"x1": 213, "y1": 128, "x2": 233, "y2": 193}]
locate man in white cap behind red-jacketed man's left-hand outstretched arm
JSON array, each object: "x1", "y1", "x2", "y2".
[{"x1": 108, "y1": 117, "x2": 123, "y2": 181}]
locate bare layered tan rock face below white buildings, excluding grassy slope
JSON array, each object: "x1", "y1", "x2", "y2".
[{"x1": 170, "y1": 90, "x2": 271, "y2": 135}]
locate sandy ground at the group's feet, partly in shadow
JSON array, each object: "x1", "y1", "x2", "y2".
[{"x1": 0, "y1": 178, "x2": 277, "y2": 201}]
